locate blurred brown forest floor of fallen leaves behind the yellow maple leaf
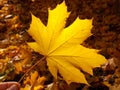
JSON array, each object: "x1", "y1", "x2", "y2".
[{"x1": 0, "y1": 0, "x2": 120, "y2": 90}]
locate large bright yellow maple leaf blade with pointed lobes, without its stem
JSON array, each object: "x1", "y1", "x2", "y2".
[{"x1": 28, "y1": 2, "x2": 106, "y2": 84}]
